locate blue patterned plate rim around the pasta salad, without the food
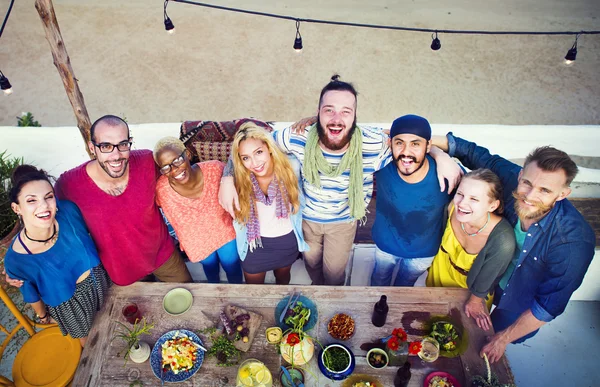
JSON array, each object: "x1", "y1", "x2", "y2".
[{"x1": 150, "y1": 329, "x2": 204, "y2": 383}]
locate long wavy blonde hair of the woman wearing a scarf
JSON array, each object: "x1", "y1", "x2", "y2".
[{"x1": 231, "y1": 122, "x2": 300, "y2": 224}]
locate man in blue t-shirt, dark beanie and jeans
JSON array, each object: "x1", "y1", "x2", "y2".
[{"x1": 371, "y1": 115, "x2": 450, "y2": 286}]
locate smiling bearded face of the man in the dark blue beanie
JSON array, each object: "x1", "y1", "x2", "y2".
[{"x1": 391, "y1": 133, "x2": 431, "y2": 180}]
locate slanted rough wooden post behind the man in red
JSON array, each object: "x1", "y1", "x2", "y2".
[{"x1": 35, "y1": 0, "x2": 92, "y2": 158}]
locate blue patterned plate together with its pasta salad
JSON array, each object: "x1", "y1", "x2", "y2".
[{"x1": 150, "y1": 329, "x2": 204, "y2": 383}]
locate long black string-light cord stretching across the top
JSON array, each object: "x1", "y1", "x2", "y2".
[{"x1": 165, "y1": 0, "x2": 600, "y2": 62}]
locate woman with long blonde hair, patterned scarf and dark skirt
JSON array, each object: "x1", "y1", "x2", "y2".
[{"x1": 231, "y1": 122, "x2": 308, "y2": 285}]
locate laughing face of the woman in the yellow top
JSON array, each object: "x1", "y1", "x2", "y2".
[{"x1": 454, "y1": 177, "x2": 500, "y2": 224}]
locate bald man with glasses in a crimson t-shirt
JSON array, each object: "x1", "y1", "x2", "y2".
[{"x1": 54, "y1": 115, "x2": 192, "y2": 286}]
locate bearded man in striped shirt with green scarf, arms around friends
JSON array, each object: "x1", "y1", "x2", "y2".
[{"x1": 219, "y1": 75, "x2": 460, "y2": 285}]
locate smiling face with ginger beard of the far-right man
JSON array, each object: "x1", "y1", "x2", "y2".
[{"x1": 513, "y1": 161, "x2": 571, "y2": 220}]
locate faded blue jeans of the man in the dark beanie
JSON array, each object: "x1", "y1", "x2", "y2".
[{"x1": 371, "y1": 247, "x2": 433, "y2": 286}]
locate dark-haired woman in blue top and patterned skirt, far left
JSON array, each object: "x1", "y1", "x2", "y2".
[{"x1": 4, "y1": 165, "x2": 112, "y2": 346}]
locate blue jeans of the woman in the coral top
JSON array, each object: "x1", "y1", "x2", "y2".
[{"x1": 200, "y1": 239, "x2": 243, "y2": 284}]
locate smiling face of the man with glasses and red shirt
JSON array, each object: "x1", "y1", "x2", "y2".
[{"x1": 88, "y1": 122, "x2": 130, "y2": 179}]
